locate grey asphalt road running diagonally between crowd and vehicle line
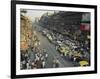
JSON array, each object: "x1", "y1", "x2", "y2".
[{"x1": 32, "y1": 23, "x2": 74, "y2": 68}]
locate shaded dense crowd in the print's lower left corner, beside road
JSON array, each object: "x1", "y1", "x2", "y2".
[{"x1": 21, "y1": 49, "x2": 48, "y2": 69}]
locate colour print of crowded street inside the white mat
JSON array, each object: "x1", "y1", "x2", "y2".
[{"x1": 20, "y1": 9, "x2": 91, "y2": 70}]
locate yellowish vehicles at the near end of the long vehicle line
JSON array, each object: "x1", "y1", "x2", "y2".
[{"x1": 56, "y1": 44, "x2": 89, "y2": 66}]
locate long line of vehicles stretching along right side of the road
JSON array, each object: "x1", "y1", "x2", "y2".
[{"x1": 42, "y1": 30, "x2": 89, "y2": 66}]
